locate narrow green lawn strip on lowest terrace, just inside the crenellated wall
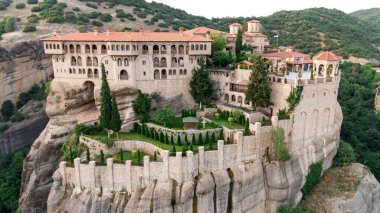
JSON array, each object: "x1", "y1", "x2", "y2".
[{"x1": 86, "y1": 132, "x2": 218, "y2": 152}]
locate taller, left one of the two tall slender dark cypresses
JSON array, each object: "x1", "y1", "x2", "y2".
[{"x1": 99, "y1": 64, "x2": 112, "y2": 137}]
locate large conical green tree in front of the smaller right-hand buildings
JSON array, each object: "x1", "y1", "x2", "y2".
[{"x1": 245, "y1": 56, "x2": 271, "y2": 109}]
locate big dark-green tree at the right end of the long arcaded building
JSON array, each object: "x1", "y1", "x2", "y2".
[{"x1": 190, "y1": 60, "x2": 213, "y2": 104}]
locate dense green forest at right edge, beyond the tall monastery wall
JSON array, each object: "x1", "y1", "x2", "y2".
[{"x1": 338, "y1": 62, "x2": 380, "y2": 180}]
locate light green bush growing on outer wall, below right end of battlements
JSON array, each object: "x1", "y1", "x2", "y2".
[{"x1": 272, "y1": 127, "x2": 291, "y2": 161}]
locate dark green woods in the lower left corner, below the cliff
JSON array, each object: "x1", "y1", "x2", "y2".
[{"x1": 0, "y1": 148, "x2": 29, "y2": 212}]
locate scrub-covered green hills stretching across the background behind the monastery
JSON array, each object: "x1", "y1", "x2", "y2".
[{"x1": 0, "y1": 0, "x2": 380, "y2": 59}]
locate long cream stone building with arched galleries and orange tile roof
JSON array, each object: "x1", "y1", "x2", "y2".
[{"x1": 43, "y1": 28, "x2": 212, "y2": 103}]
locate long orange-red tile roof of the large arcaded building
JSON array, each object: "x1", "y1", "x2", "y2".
[{"x1": 42, "y1": 32, "x2": 212, "y2": 42}]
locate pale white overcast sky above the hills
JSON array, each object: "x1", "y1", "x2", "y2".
[{"x1": 148, "y1": 0, "x2": 380, "y2": 18}]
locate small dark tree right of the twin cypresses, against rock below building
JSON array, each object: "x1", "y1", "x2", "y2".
[{"x1": 132, "y1": 90, "x2": 152, "y2": 123}]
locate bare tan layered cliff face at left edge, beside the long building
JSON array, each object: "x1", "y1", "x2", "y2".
[{"x1": 0, "y1": 41, "x2": 53, "y2": 103}]
